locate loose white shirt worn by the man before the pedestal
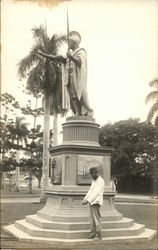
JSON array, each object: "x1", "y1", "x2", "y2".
[{"x1": 84, "y1": 176, "x2": 105, "y2": 206}]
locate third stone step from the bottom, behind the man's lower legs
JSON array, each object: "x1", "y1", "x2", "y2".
[{"x1": 25, "y1": 214, "x2": 134, "y2": 230}]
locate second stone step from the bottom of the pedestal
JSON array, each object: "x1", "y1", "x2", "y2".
[{"x1": 15, "y1": 220, "x2": 145, "y2": 239}]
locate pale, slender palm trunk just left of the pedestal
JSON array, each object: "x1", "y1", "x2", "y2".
[{"x1": 40, "y1": 94, "x2": 50, "y2": 203}]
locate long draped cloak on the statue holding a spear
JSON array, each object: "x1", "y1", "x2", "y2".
[{"x1": 62, "y1": 48, "x2": 92, "y2": 114}]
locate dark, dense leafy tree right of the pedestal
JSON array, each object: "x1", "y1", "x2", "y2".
[{"x1": 100, "y1": 119, "x2": 158, "y2": 181}]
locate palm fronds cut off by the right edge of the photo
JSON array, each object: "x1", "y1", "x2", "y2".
[{"x1": 145, "y1": 79, "x2": 158, "y2": 126}]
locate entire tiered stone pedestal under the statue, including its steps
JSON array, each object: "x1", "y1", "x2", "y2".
[{"x1": 6, "y1": 117, "x2": 155, "y2": 241}]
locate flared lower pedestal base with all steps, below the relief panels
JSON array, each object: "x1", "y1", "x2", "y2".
[{"x1": 4, "y1": 190, "x2": 156, "y2": 242}]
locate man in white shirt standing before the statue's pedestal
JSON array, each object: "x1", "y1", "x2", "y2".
[{"x1": 82, "y1": 167, "x2": 105, "y2": 240}]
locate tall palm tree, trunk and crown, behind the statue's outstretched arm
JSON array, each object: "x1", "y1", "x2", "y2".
[{"x1": 18, "y1": 26, "x2": 65, "y2": 203}]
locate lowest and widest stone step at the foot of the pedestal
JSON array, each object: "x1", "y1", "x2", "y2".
[{"x1": 3, "y1": 224, "x2": 156, "y2": 243}]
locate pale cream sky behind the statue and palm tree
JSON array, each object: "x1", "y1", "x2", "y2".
[{"x1": 1, "y1": 0, "x2": 158, "y2": 125}]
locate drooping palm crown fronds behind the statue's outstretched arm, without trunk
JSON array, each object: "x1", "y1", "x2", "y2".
[{"x1": 18, "y1": 25, "x2": 66, "y2": 113}]
